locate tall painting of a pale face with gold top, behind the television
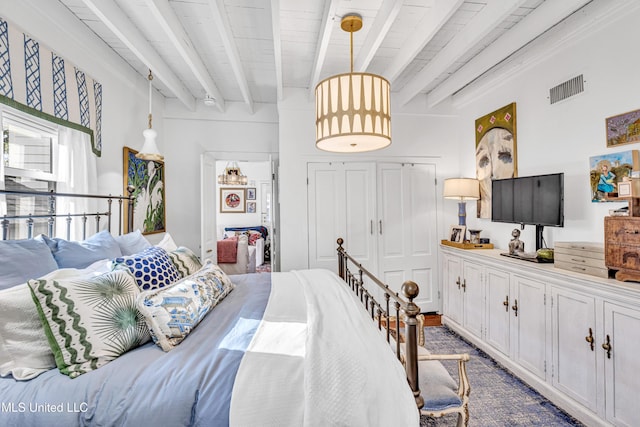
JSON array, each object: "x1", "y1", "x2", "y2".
[{"x1": 475, "y1": 102, "x2": 518, "y2": 218}]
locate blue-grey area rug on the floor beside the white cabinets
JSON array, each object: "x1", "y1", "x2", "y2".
[{"x1": 420, "y1": 326, "x2": 582, "y2": 427}]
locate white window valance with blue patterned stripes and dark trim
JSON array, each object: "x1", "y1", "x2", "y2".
[{"x1": 0, "y1": 18, "x2": 102, "y2": 156}]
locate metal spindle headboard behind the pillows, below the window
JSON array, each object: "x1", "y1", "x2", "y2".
[{"x1": 0, "y1": 187, "x2": 134, "y2": 240}]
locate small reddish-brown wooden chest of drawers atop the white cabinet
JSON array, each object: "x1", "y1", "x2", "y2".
[{"x1": 604, "y1": 216, "x2": 640, "y2": 281}]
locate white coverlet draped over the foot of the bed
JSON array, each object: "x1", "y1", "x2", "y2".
[{"x1": 230, "y1": 270, "x2": 419, "y2": 426}]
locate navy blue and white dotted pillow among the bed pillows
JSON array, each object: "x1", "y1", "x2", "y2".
[{"x1": 113, "y1": 246, "x2": 182, "y2": 291}]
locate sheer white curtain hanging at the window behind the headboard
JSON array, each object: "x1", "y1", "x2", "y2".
[{"x1": 56, "y1": 126, "x2": 97, "y2": 240}]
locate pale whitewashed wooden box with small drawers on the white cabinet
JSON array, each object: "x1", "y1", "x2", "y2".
[{"x1": 554, "y1": 242, "x2": 609, "y2": 279}]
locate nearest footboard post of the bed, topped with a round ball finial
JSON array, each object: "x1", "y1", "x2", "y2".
[{"x1": 401, "y1": 280, "x2": 424, "y2": 408}]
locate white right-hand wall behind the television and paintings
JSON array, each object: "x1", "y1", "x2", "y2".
[{"x1": 454, "y1": 1, "x2": 640, "y2": 251}]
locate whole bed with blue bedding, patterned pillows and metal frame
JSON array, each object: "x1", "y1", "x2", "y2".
[{"x1": 0, "y1": 191, "x2": 422, "y2": 426}]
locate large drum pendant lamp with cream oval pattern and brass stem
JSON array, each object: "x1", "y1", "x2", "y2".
[{"x1": 316, "y1": 15, "x2": 391, "y2": 153}]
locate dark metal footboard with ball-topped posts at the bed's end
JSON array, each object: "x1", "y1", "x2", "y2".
[{"x1": 337, "y1": 238, "x2": 424, "y2": 408}]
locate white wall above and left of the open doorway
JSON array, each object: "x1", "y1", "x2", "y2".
[{"x1": 163, "y1": 99, "x2": 278, "y2": 252}]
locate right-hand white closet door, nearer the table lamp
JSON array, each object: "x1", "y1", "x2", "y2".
[{"x1": 377, "y1": 163, "x2": 440, "y2": 312}]
